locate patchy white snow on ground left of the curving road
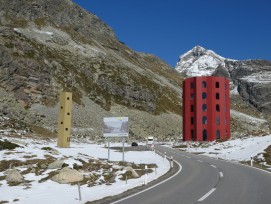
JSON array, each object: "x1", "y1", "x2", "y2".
[{"x1": 0, "y1": 137, "x2": 170, "y2": 204}]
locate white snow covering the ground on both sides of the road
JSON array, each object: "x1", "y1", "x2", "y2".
[{"x1": 0, "y1": 135, "x2": 271, "y2": 204}]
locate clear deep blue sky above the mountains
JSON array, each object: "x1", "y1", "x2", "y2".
[{"x1": 74, "y1": 0, "x2": 271, "y2": 67}]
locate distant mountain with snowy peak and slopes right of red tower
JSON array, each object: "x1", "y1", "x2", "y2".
[{"x1": 176, "y1": 46, "x2": 271, "y2": 135}]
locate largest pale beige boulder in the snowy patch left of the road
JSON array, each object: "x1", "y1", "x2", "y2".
[{"x1": 51, "y1": 167, "x2": 84, "y2": 184}]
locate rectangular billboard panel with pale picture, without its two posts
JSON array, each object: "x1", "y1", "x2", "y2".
[{"x1": 104, "y1": 117, "x2": 129, "y2": 137}]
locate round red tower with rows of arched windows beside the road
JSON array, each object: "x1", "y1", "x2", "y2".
[{"x1": 183, "y1": 76, "x2": 230, "y2": 141}]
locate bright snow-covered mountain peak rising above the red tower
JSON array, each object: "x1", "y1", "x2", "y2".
[{"x1": 176, "y1": 46, "x2": 234, "y2": 76}]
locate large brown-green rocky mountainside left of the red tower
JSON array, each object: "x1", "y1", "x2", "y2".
[{"x1": 0, "y1": 0, "x2": 183, "y2": 139}]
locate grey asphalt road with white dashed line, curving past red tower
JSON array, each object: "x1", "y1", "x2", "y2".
[{"x1": 114, "y1": 146, "x2": 271, "y2": 204}]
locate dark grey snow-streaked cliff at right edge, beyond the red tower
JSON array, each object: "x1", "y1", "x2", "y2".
[{"x1": 225, "y1": 60, "x2": 271, "y2": 113}]
